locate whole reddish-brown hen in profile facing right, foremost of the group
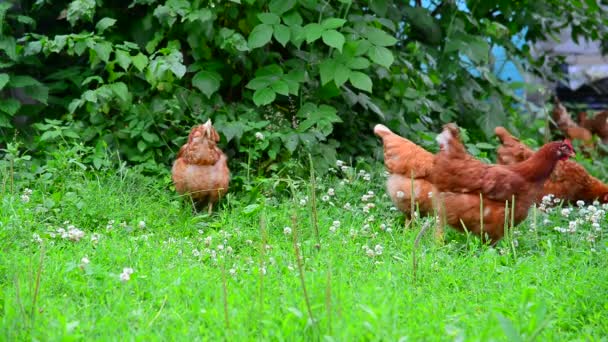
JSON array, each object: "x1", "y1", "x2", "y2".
[{"x1": 431, "y1": 124, "x2": 574, "y2": 243}]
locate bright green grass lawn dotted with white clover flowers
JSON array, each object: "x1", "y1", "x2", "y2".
[{"x1": 0, "y1": 157, "x2": 608, "y2": 341}]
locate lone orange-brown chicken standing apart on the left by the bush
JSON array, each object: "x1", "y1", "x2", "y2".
[{"x1": 171, "y1": 120, "x2": 230, "y2": 213}]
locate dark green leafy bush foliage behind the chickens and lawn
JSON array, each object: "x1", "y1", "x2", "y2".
[{"x1": 0, "y1": 0, "x2": 608, "y2": 173}]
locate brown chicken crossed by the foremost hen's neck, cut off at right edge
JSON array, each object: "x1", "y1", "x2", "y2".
[{"x1": 495, "y1": 127, "x2": 608, "y2": 203}]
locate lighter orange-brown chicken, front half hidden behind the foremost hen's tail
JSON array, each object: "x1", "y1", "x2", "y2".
[{"x1": 374, "y1": 124, "x2": 434, "y2": 218}]
